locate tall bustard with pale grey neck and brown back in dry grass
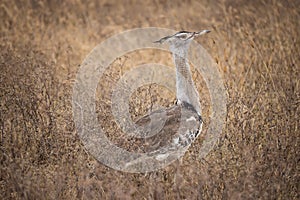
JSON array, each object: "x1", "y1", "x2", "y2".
[{"x1": 132, "y1": 30, "x2": 210, "y2": 160}]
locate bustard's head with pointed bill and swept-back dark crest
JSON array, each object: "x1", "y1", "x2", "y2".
[{"x1": 155, "y1": 30, "x2": 210, "y2": 46}]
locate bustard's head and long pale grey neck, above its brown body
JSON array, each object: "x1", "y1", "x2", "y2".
[{"x1": 155, "y1": 30, "x2": 210, "y2": 116}]
